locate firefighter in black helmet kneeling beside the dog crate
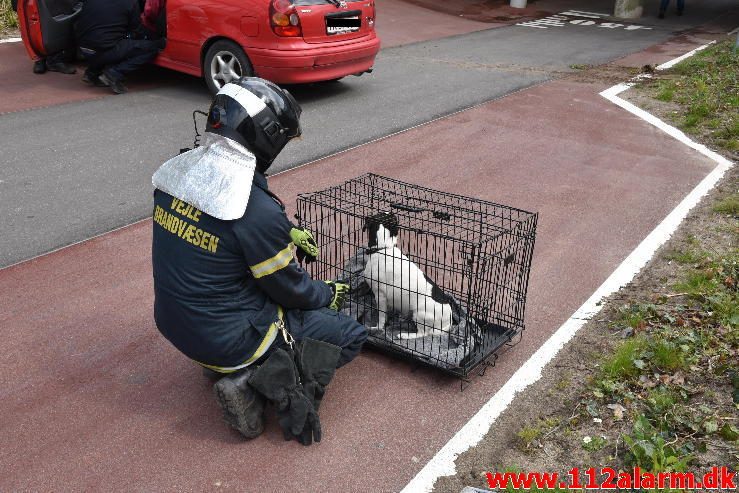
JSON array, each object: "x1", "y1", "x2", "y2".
[{"x1": 152, "y1": 77, "x2": 367, "y2": 445}]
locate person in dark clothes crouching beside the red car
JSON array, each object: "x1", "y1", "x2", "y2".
[{"x1": 75, "y1": 0, "x2": 164, "y2": 94}]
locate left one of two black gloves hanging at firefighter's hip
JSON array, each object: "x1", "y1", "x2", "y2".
[{"x1": 249, "y1": 349, "x2": 321, "y2": 445}]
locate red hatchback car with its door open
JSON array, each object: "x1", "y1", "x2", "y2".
[{"x1": 18, "y1": 0, "x2": 380, "y2": 92}]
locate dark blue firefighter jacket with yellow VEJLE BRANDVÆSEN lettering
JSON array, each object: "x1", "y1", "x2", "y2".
[{"x1": 152, "y1": 173, "x2": 333, "y2": 368}]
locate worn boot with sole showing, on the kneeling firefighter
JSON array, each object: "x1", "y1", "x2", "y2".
[{"x1": 213, "y1": 369, "x2": 264, "y2": 438}]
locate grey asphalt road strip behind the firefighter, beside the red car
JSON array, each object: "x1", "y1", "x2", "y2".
[{"x1": 0, "y1": 15, "x2": 700, "y2": 267}]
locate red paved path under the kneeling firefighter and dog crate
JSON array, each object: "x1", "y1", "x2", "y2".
[{"x1": 0, "y1": 72, "x2": 713, "y2": 492}]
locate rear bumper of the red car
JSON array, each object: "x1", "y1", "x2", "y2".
[{"x1": 248, "y1": 36, "x2": 380, "y2": 84}]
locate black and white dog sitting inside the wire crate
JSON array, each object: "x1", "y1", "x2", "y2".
[{"x1": 364, "y1": 212, "x2": 452, "y2": 339}]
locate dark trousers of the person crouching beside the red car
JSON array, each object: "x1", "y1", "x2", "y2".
[{"x1": 81, "y1": 38, "x2": 163, "y2": 80}]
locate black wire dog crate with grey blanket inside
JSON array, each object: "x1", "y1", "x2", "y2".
[{"x1": 296, "y1": 174, "x2": 537, "y2": 378}]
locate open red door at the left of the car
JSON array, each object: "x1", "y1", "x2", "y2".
[{"x1": 18, "y1": 0, "x2": 82, "y2": 60}]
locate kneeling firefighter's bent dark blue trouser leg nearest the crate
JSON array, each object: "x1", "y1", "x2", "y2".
[{"x1": 287, "y1": 308, "x2": 367, "y2": 367}]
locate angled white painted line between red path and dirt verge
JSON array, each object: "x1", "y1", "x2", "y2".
[{"x1": 401, "y1": 41, "x2": 733, "y2": 493}]
